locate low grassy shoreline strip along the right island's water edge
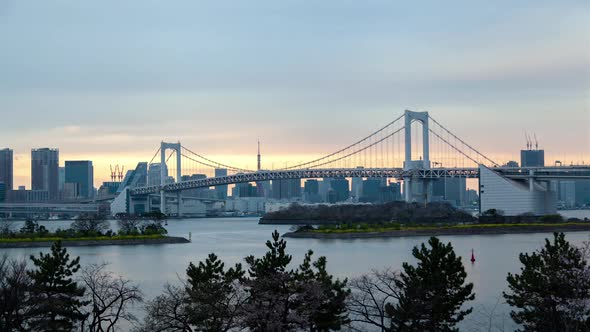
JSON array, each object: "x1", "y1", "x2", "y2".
[{"x1": 283, "y1": 223, "x2": 590, "y2": 239}]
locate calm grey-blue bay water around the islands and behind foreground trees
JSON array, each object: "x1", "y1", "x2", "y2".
[{"x1": 1, "y1": 211, "x2": 590, "y2": 331}]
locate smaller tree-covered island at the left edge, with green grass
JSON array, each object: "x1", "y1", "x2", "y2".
[{"x1": 0, "y1": 212, "x2": 190, "y2": 248}]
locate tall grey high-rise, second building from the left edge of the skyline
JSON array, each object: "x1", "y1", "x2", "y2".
[{"x1": 31, "y1": 148, "x2": 59, "y2": 199}]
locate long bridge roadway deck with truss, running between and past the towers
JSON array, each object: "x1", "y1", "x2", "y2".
[{"x1": 130, "y1": 166, "x2": 590, "y2": 195}]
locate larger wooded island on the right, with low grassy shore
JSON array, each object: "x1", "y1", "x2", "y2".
[{"x1": 260, "y1": 202, "x2": 590, "y2": 239}]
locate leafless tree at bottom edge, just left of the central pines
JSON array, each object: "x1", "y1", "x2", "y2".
[{"x1": 136, "y1": 285, "x2": 194, "y2": 332}]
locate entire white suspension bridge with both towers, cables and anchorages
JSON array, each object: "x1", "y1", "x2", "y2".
[{"x1": 111, "y1": 110, "x2": 590, "y2": 216}]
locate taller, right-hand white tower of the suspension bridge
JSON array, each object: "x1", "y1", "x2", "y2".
[{"x1": 404, "y1": 110, "x2": 430, "y2": 202}]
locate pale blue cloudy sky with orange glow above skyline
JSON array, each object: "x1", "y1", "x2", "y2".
[{"x1": 0, "y1": 0, "x2": 590, "y2": 188}]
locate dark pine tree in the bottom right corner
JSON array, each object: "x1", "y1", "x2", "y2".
[{"x1": 504, "y1": 233, "x2": 590, "y2": 332}]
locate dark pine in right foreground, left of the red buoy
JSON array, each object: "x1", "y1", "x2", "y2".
[{"x1": 386, "y1": 237, "x2": 475, "y2": 332}]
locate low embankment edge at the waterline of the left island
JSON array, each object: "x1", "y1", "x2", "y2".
[{"x1": 0, "y1": 236, "x2": 190, "y2": 248}]
